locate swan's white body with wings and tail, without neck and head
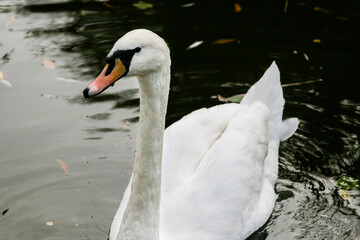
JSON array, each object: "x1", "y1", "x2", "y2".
[{"x1": 110, "y1": 63, "x2": 298, "y2": 240}]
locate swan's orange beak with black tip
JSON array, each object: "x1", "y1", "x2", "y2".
[{"x1": 83, "y1": 58, "x2": 126, "y2": 98}]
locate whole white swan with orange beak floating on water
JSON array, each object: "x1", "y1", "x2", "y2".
[{"x1": 83, "y1": 29, "x2": 299, "y2": 240}]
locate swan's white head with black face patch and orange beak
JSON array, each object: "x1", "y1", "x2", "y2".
[{"x1": 83, "y1": 29, "x2": 170, "y2": 98}]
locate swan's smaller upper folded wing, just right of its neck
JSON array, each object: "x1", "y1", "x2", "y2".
[{"x1": 162, "y1": 104, "x2": 239, "y2": 191}]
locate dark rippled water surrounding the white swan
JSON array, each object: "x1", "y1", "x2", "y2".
[{"x1": 0, "y1": 0, "x2": 360, "y2": 240}]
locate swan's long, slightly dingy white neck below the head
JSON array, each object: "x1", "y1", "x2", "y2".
[{"x1": 117, "y1": 61, "x2": 170, "y2": 240}]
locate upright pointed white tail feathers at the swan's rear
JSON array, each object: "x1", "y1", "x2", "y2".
[{"x1": 241, "y1": 61, "x2": 299, "y2": 140}]
